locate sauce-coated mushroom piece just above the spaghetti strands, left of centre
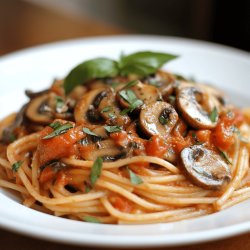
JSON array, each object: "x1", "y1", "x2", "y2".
[{"x1": 80, "y1": 139, "x2": 126, "y2": 161}]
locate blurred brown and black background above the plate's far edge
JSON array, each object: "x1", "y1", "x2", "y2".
[{"x1": 0, "y1": 0, "x2": 250, "y2": 55}]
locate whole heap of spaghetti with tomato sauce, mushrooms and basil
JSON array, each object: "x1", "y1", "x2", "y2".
[{"x1": 0, "y1": 51, "x2": 250, "y2": 224}]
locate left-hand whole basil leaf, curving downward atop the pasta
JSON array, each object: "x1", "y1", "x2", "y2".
[{"x1": 64, "y1": 58, "x2": 119, "y2": 94}]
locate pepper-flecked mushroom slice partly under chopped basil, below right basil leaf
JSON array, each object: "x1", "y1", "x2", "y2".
[{"x1": 117, "y1": 81, "x2": 161, "y2": 108}]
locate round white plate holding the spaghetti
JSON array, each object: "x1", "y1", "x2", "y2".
[{"x1": 0, "y1": 36, "x2": 250, "y2": 247}]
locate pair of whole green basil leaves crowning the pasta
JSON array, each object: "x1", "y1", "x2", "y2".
[{"x1": 64, "y1": 51, "x2": 177, "y2": 94}]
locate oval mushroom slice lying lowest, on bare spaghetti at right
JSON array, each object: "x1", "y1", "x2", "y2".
[{"x1": 180, "y1": 145, "x2": 231, "y2": 189}]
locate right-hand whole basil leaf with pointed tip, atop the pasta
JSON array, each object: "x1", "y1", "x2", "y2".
[{"x1": 119, "y1": 51, "x2": 177, "y2": 76}]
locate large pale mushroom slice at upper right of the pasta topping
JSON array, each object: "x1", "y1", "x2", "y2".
[{"x1": 176, "y1": 86, "x2": 217, "y2": 129}]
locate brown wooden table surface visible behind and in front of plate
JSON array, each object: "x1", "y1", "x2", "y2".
[{"x1": 0, "y1": 0, "x2": 250, "y2": 250}]
